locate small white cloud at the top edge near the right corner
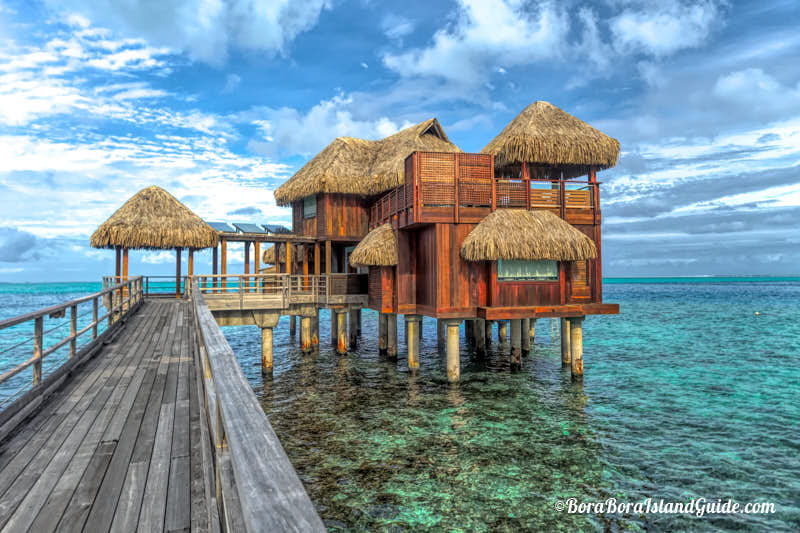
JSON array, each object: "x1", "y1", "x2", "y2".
[{"x1": 609, "y1": 0, "x2": 720, "y2": 57}]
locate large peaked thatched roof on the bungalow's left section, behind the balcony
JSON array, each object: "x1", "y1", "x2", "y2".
[{"x1": 275, "y1": 118, "x2": 461, "y2": 205}]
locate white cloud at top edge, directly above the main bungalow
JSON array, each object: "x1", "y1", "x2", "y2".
[{"x1": 383, "y1": 0, "x2": 569, "y2": 85}]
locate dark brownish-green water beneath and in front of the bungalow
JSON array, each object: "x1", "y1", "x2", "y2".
[{"x1": 225, "y1": 312, "x2": 620, "y2": 531}]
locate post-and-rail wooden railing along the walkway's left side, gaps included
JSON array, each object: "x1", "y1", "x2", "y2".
[{"x1": 0, "y1": 276, "x2": 143, "y2": 435}]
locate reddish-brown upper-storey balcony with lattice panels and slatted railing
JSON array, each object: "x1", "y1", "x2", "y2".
[{"x1": 369, "y1": 152, "x2": 600, "y2": 229}]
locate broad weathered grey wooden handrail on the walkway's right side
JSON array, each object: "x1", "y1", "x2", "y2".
[{"x1": 192, "y1": 277, "x2": 326, "y2": 532}]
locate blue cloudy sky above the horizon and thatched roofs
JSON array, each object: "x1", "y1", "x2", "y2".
[{"x1": 0, "y1": 0, "x2": 800, "y2": 282}]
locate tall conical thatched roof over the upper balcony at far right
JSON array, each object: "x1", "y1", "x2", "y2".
[{"x1": 481, "y1": 101, "x2": 619, "y2": 177}]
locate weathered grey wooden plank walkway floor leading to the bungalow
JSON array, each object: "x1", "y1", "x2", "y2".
[{"x1": 0, "y1": 300, "x2": 216, "y2": 532}]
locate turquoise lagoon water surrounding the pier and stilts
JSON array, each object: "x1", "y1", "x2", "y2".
[{"x1": 0, "y1": 278, "x2": 800, "y2": 531}]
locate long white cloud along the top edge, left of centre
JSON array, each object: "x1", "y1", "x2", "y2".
[{"x1": 46, "y1": 0, "x2": 329, "y2": 64}]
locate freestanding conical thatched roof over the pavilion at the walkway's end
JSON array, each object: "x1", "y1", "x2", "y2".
[{"x1": 91, "y1": 187, "x2": 219, "y2": 250}]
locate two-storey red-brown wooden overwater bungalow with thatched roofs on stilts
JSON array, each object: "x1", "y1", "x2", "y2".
[{"x1": 275, "y1": 102, "x2": 619, "y2": 380}]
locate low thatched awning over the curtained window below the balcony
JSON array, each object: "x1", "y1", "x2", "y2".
[{"x1": 461, "y1": 209, "x2": 597, "y2": 261}]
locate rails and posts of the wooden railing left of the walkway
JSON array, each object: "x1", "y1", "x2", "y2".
[{"x1": 0, "y1": 276, "x2": 143, "y2": 428}]
